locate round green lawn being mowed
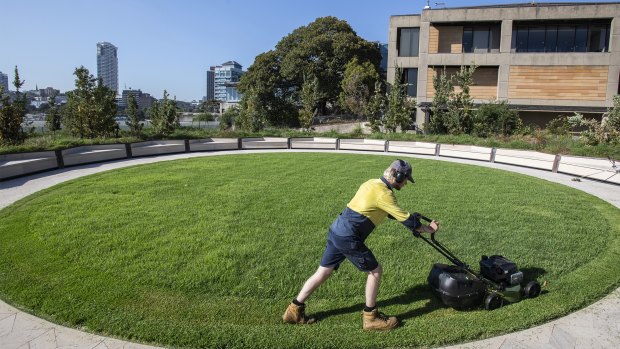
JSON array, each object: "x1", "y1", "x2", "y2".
[{"x1": 0, "y1": 153, "x2": 620, "y2": 348}]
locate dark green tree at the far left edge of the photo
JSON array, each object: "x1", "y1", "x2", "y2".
[{"x1": 0, "y1": 66, "x2": 27, "y2": 145}]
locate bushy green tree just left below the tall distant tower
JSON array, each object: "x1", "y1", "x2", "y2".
[{"x1": 64, "y1": 66, "x2": 119, "y2": 138}]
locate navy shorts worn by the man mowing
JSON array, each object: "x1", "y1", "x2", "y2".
[{"x1": 321, "y1": 229, "x2": 379, "y2": 272}]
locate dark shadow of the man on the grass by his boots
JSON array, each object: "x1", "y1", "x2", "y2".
[{"x1": 312, "y1": 284, "x2": 442, "y2": 321}]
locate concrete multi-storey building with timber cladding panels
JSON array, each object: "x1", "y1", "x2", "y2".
[{"x1": 388, "y1": 2, "x2": 620, "y2": 125}]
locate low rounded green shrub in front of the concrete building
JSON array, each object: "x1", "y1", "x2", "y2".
[{"x1": 472, "y1": 101, "x2": 522, "y2": 137}]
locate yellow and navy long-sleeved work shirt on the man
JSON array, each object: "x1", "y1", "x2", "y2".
[{"x1": 330, "y1": 178, "x2": 421, "y2": 240}]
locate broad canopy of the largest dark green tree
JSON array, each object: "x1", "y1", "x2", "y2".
[{"x1": 239, "y1": 17, "x2": 381, "y2": 128}]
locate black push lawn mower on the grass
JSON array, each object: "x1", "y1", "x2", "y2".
[{"x1": 416, "y1": 213, "x2": 541, "y2": 310}]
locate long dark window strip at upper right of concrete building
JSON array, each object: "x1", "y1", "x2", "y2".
[{"x1": 512, "y1": 21, "x2": 610, "y2": 52}]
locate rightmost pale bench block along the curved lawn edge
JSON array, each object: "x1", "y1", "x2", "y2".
[{"x1": 558, "y1": 155, "x2": 620, "y2": 184}]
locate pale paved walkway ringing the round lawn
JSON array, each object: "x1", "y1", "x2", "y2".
[{"x1": 0, "y1": 150, "x2": 620, "y2": 349}]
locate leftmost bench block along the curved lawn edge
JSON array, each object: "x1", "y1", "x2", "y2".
[{"x1": 0, "y1": 151, "x2": 58, "y2": 180}]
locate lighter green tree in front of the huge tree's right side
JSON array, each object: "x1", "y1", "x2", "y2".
[{"x1": 340, "y1": 57, "x2": 380, "y2": 116}]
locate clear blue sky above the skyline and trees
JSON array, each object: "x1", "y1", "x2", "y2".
[{"x1": 0, "y1": 0, "x2": 613, "y2": 101}]
